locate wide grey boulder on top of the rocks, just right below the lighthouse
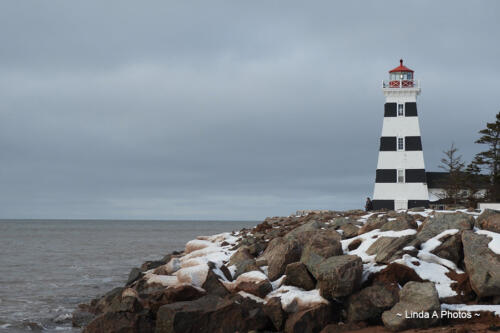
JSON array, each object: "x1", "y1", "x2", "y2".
[{"x1": 417, "y1": 212, "x2": 474, "y2": 243}]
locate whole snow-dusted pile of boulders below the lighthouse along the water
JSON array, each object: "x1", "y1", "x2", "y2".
[{"x1": 73, "y1": 209, "x2": 500, "y2": 333}]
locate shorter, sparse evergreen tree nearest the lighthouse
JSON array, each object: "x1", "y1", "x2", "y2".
[{"x1": 439, "y1": 143, "x2": 465, "y2": 204}]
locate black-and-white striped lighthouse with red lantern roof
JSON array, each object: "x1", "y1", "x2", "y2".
[{"x1": 373, "y1": 60, "x2": 429, "y2": 210}]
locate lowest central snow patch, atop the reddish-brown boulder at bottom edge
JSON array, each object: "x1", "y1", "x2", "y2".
[{"x1": 266, "y1": 286, "x2": 328, "y2": 312}]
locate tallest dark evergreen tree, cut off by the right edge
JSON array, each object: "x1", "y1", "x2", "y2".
[{"x1": 474, "y1": 112, "x2": 500, "y2": 202}]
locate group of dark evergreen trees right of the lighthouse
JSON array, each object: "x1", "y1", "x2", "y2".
[{"x1": 439, "y1": 112, "x2": 500, "y2": 207}]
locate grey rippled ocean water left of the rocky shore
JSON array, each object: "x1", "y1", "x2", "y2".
[{"x1": 0, "y1": 220, "x2": 257, "y2": 333}]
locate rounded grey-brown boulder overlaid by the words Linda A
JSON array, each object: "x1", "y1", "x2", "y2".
[{"x1": 382, "y1": 282, "x2": 441, "y2": 331}]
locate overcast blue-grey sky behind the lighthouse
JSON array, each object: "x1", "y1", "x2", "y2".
[{"x1": 0, "y1": 0, "x2": 500, "y2": 219}]
